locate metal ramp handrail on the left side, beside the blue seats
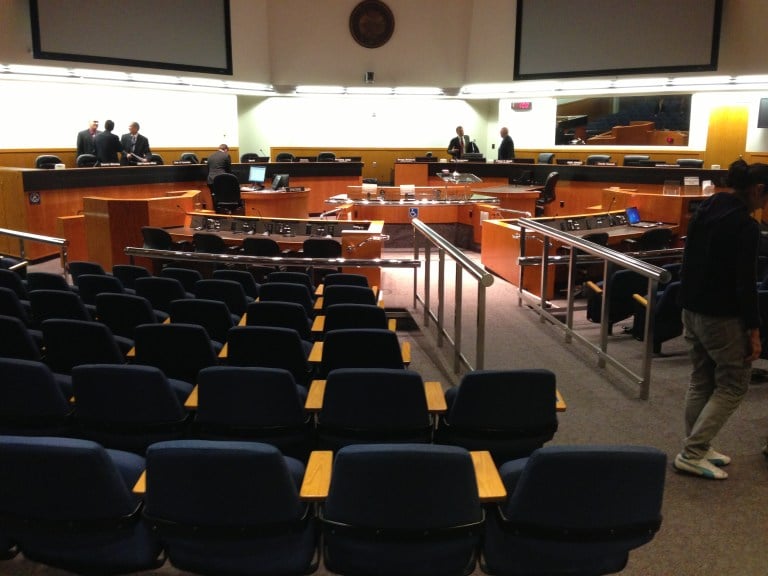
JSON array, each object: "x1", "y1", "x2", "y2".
[{"x1": 411, "y1": 218, "x2": 494, "y2": 374}]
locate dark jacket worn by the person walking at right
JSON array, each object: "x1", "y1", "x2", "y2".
[{"x1": 680, "y1": 192, "x2": 760, "y2": 328}]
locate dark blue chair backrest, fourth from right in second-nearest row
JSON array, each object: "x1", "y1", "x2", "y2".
[{"x1": 72, "y1": 364, "x2": 192, "y2": 454}]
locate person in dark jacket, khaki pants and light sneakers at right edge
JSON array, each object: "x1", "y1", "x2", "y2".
[{"x1": 673, "y1": 159, "x2": 768, "y2": 480}]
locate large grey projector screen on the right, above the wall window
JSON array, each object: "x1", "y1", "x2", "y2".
[{"x1": 514, "y1": 0, "x2": 722, "y2": 80}]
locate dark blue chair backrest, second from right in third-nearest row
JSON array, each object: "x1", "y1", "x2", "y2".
[{"x1": 227, "y1": 326, "x2": 312, "y2": 387}]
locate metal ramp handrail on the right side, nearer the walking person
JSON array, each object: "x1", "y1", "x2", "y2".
[{"x1": 517, "y1": 218, "x2": 682, "y2": 400}]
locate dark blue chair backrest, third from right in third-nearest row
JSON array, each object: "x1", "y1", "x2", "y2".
[{"x1": 134, "y1": 323, "x2": 218, "y2": 383}]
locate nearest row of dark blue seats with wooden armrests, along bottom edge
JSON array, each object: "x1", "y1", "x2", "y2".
[{"x1": 0, "y1": 436, "x2": 666, "y2": 576}]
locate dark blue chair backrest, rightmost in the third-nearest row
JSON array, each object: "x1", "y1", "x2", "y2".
[{"x1": 320, "y1": 328, "x2": 405, "y2": 376}]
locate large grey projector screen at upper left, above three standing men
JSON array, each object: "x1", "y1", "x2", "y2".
[{"x1": 29, "y1": 0, "x2": 232, "y2": 75}]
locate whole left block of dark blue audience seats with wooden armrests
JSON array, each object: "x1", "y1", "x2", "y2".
[{"x1": 0, "y1": 265, "x2": 665, "y2": 575}]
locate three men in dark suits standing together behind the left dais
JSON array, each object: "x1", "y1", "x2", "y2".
[{"x1": 77, "y1": 120, "x2": 152, "y2": 164}]
